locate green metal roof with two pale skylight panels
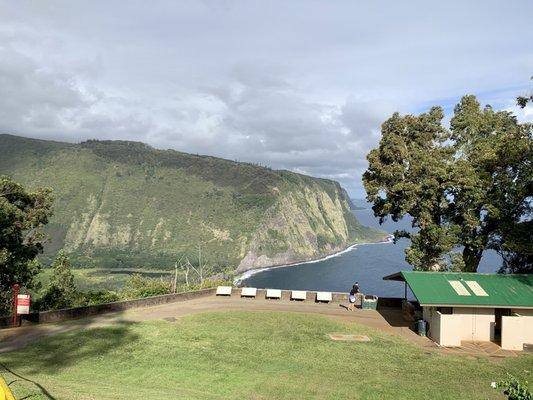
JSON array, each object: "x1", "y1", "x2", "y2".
[{"x1": 383, "y1": 271, "x2": 533, "y2": 308}]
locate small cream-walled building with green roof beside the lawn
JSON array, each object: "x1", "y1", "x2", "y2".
[{"x1": 383, "y1": 271, "x2": 533, "y2": 350}]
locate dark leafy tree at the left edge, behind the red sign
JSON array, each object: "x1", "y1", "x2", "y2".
[{"x1": 0, "y1": 176, "x2": 53, "y2": 314}]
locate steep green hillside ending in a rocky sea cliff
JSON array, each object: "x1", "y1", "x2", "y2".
[{"x1": 0, "y1": 135, "x2": 384, "y2": 271}]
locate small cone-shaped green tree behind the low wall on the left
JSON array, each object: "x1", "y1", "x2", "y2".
[{"x1": 36, "y1": 250, "x2": 80, "y2": 310}]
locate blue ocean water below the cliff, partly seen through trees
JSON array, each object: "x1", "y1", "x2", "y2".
[{"x1": 242, "y1": 209, "x2": 501, "y2": 297}]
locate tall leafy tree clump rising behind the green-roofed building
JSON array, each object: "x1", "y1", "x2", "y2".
[{"x1": 363, "y1": 96, "x2": 533, "y2": 271}]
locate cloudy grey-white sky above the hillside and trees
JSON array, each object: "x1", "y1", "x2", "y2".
[{"x1": 0, "y1": 0, "x2": 533, "y2": 198}]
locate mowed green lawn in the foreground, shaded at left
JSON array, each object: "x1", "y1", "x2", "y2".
[{"x1": 0, "y1": 312, "x2": 533, "y2": 400}]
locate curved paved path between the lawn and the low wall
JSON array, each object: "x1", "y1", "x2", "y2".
[{"x1": 0, "y1": 295, "x2": 515, "y2": 357}]
